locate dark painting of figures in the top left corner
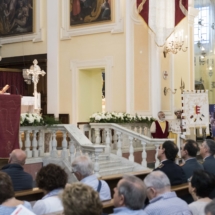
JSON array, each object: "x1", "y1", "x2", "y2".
[{"x1": 0, "y1": 0, "x2": 34, "y2": 37}]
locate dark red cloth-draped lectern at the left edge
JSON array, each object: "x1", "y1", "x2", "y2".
[{"x1": 0, "y1": 94, "x2": 21, "y2": 158}]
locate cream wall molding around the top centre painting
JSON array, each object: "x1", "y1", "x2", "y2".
[{"x1": 60, "y1": 0, "x2": 124, "y2": 40}]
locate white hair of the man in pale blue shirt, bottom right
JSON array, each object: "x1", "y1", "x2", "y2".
[{"x1": 144, "y1": 171, "x2": 171, "y2": 190}]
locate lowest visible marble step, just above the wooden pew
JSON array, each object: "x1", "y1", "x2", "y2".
[{"x1": 99, "y1": 166, "x2": 133, "y2": 176}]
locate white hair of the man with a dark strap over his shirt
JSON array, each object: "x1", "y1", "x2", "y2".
[{"x1": 72, "y1": 155, "x2": 94, "y2": 177}]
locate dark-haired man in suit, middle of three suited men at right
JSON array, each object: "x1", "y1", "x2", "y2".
[{"x1": 181, "y1": 140, "x2": 203, "y2": 179}]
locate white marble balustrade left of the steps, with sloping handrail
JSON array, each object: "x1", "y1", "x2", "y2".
[{"x1": 19, "y1": 125, "x2": 105, "y2": 174}]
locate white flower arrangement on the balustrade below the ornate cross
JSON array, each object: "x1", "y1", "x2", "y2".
[{"x1": 20, "y1": 113, "x2": 44, "y2": 126}]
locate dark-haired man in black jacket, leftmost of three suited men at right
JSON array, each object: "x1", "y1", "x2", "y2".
[{"x1": 154, "y1": 141, "x2": 187, "y2": 185}]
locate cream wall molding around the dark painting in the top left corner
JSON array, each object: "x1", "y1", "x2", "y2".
[{"x1": 0, "y1": 0, "x2": 43, "y2": 45}]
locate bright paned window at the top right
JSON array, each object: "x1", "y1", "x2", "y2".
[{"x1": 194, "y1": 6, "x2": 209, "y2": 44}]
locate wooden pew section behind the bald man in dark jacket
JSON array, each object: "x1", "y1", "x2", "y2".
[{"x1": 15, "y1": 187, "x2": 44, "y2": 202}]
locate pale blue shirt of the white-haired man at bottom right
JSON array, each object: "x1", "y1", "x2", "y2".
[{"x1": 144, "y1": 192, "x2": 192, "y2": 215}]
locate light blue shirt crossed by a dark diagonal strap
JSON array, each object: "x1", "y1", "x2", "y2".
[{"x1": 80, "y1": 174, "x2": 111, "y2": 201}]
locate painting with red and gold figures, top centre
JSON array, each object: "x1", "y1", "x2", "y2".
[{"x1": 70, "y1": 0, "x2": 111, "y2": 26}]
